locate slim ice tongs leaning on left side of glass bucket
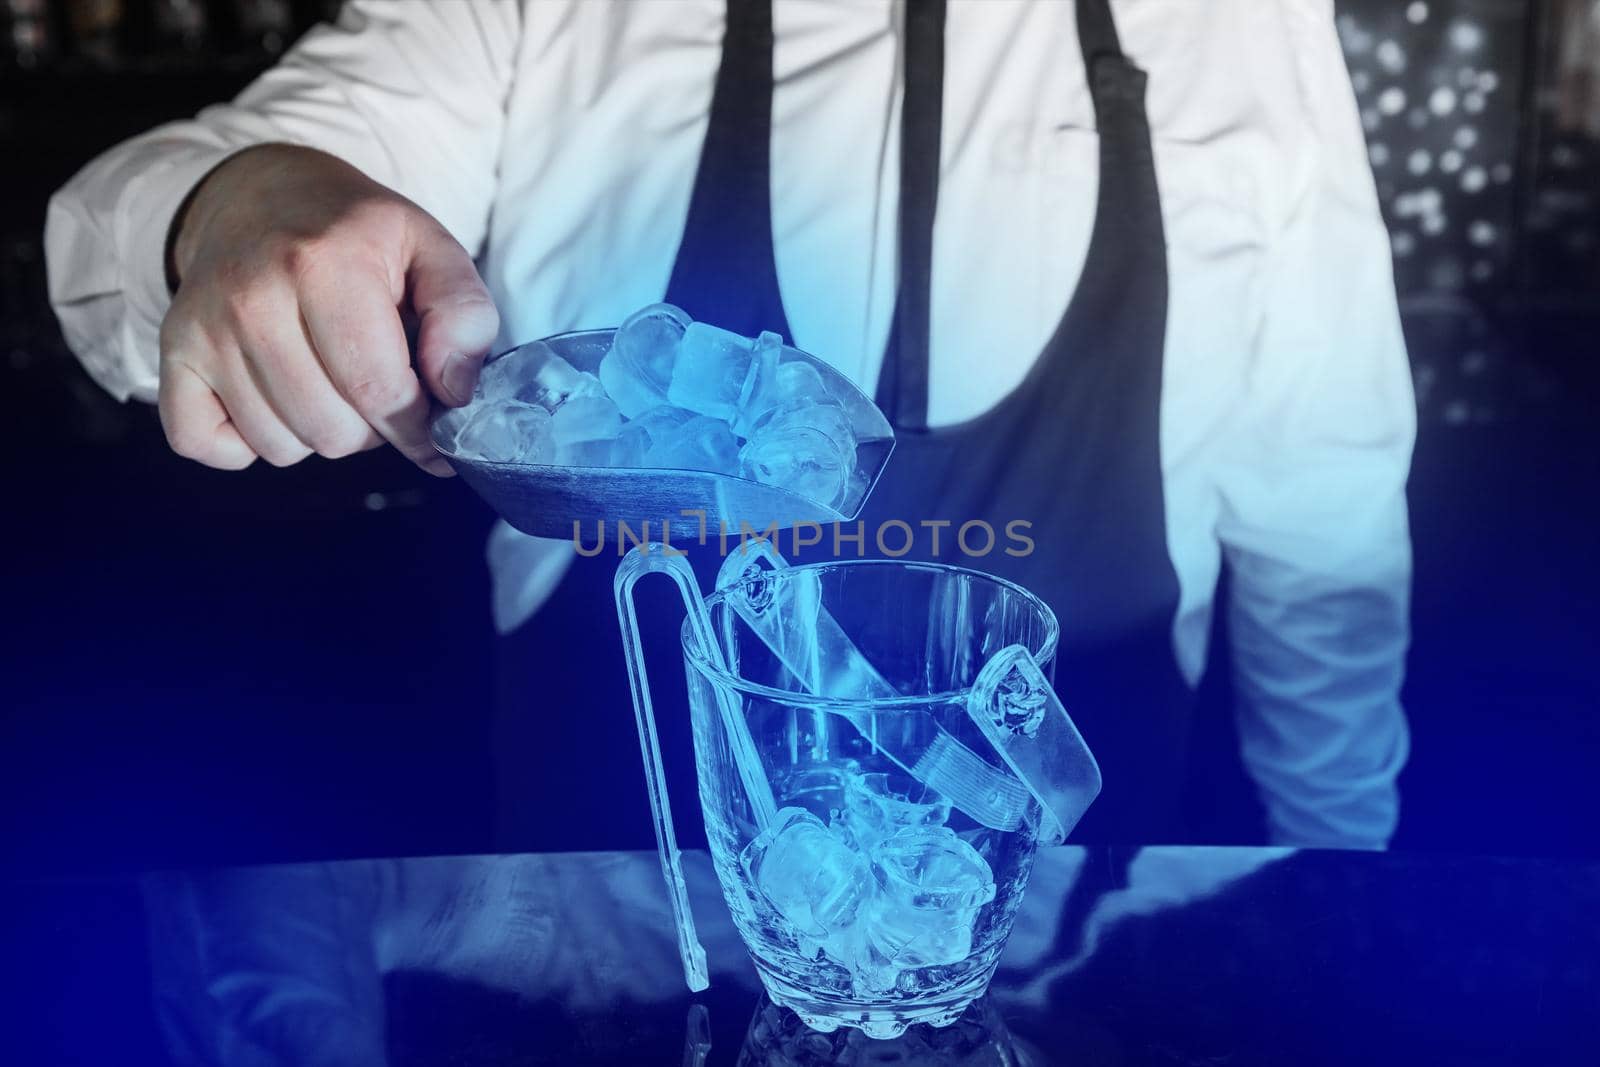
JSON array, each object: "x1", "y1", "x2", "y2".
[{"x1": 613, "y1": 542, "x2": 778, "y2": 992}]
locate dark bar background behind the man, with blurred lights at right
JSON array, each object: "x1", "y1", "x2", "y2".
[{"x1": 0, "y1": 0, "x2": 1600, "y2": 872}]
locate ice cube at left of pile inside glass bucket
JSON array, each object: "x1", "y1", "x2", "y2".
[{"x1": 739, "y1": 808, "x2": 877, "y2": 958}]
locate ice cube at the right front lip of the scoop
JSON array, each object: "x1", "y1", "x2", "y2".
[{"x1": 739, "y1": 400, "x2": 856, "y2": 506}]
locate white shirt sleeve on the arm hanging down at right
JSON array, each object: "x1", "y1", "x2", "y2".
[{"x1": 1218, "y1": 2, "x2": 1416, "y2": 848}]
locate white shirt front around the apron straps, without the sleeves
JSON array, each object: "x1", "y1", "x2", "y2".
[{"x1": 483, "y1": 0, "x2": 1338, "y2": 681}]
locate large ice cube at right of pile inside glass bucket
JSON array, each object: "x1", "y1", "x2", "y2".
[{"x1": 856, "y1": 825, "x2": 995, "y2": 984}]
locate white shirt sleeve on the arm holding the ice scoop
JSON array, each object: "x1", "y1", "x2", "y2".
[{"x1": 45, "y1": 0, "x2": 520, "y2": 400}]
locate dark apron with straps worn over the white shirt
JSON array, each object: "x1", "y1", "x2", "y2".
[{"x1": 494, "y1": 0, "x2": 1194, "y2": 851}]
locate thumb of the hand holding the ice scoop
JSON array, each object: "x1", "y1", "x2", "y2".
[{"x1": 406, "y1": 224, "x2": 499, "y2": 408}]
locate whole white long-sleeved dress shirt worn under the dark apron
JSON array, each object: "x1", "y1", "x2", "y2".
[{"x1": 46, "y1": 0, "x2": 1414, "y2": 846}]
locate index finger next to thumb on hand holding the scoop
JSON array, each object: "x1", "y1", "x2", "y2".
[{"x1": 301, "y1": 271, "x2": 451, "y2": 475}]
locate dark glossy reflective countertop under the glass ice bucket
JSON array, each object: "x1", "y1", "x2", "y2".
[{"x1": 0, "y1": 846, "x2": 1600, "y2": 1067}]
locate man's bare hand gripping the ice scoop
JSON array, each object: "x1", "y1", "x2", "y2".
[{"x1": 160, "y1": 144, "x2": 499, "y2": 475}]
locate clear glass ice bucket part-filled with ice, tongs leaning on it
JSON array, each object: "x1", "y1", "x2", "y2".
[{"x1": 618, "y1": 552, "x2": 1099, "y2": 1038}]
